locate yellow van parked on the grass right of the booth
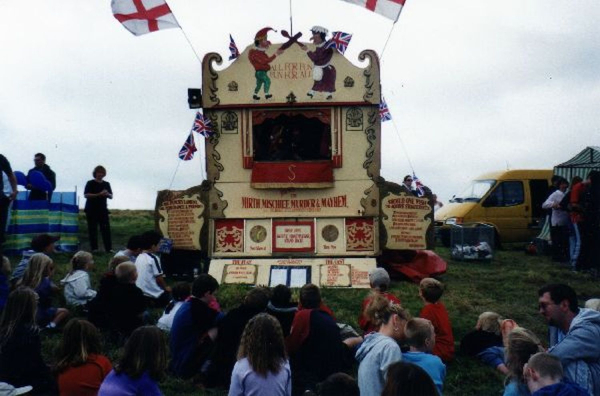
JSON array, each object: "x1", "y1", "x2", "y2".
[{"x1": 435, "y1": 169, "x2": 552, "y2": 246}]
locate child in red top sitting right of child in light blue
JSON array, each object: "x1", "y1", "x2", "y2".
[{"x1": 419, "y1": 278, "x2": 454, "y2": 362}]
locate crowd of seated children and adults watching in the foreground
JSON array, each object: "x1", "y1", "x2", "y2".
[{"x1": 0, "y1": 231, "x2": 600, "y2": 396}]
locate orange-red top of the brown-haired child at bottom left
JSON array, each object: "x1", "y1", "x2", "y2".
[{"x1": 58, "y1": 355, "x2": 112, "y2": 396}]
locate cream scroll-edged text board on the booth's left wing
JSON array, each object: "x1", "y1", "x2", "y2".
[{"x1": 158, "y1": 191, "x2": 204, "y2": 250}]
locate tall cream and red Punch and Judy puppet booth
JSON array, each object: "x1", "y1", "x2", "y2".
[{"x1": 156, "y1": 26, "x2": 445, "y2": 288}]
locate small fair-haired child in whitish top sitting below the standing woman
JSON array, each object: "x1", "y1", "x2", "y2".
[{"x1": 60, "y1": 250, "x2": 96, "y2": 306}]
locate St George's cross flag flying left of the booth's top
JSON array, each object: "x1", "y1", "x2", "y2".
[{"x1": 111, "y1": 0, "x2": 180, "y2": 36}]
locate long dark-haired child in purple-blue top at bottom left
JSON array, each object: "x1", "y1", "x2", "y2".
[{"x1": 98, "y1": 326, "x2": 168, "y2": 396}]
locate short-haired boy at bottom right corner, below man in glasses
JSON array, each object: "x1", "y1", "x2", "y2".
[{"x1": 523, "y1": 352, "x2": 589, "y2": 396}]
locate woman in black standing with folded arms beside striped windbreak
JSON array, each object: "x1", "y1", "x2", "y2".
[{"x1": 83, "y1": 165, "x2": 112, "y2": 253}]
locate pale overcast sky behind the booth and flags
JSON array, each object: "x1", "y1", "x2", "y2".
[{"x1": 0, "y1": 0, "x2": 600, "y2": 209}]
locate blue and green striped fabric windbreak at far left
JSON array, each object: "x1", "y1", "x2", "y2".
[{"x1": 4, "y1": 191, "x2": 79, "y2": 255}]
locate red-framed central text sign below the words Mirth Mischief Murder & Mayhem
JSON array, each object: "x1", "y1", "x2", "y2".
[{"x1": 273, "y1": 221, "x2": 315, "y2": 252}]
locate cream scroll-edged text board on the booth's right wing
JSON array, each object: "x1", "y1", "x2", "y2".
[{"x1": 381, "y1": 193, "x2": 431, "y2": 250}]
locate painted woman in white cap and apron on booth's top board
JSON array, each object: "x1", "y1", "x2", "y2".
[{"x1": 300, "y1": 26, "x2": 336, "y2": 100}]
